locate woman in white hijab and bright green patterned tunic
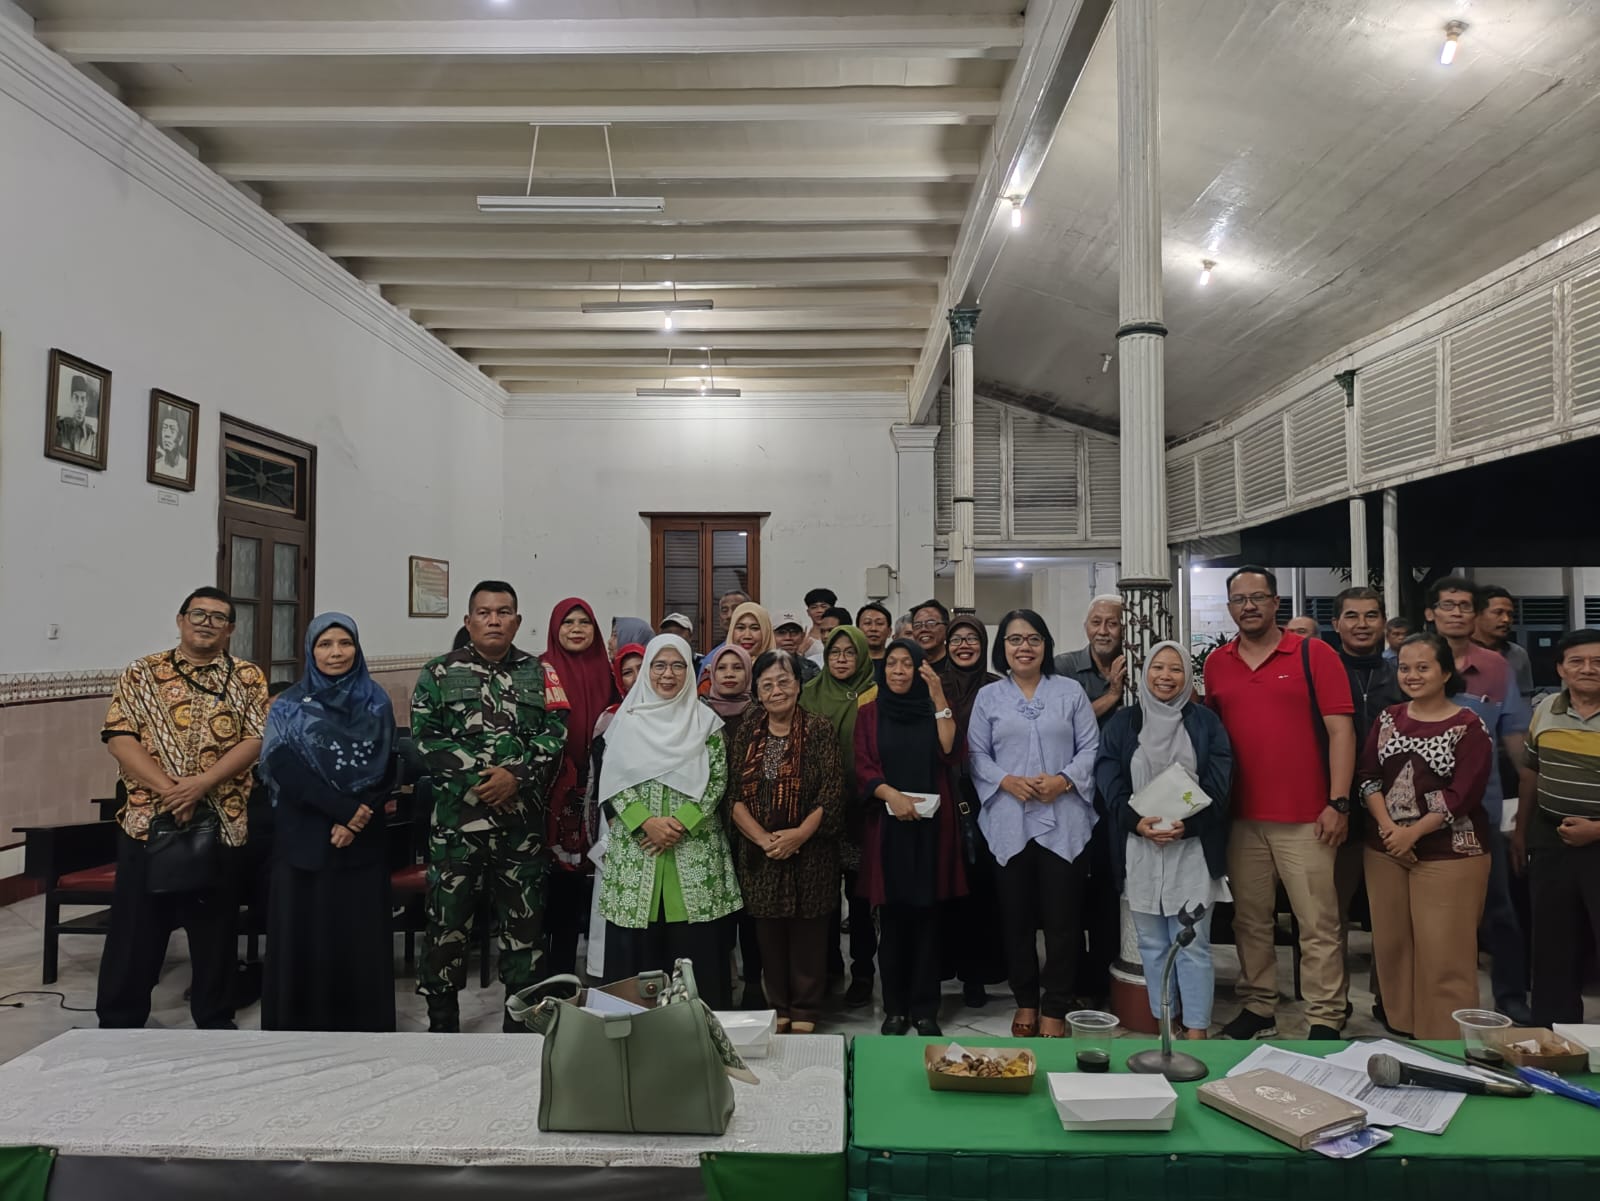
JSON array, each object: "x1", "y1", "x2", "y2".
[{"x1": 598, "y1": 633, "x2": 741, "y2": 1009}]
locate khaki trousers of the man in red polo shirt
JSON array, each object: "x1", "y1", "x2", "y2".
[{"x1": 1227, "y1": 820, "x2": 1346, "y2": 1030}]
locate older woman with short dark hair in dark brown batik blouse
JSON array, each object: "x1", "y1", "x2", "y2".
[{"x1": 728, "y1": 651, "x2": 845, "y2": 1035}]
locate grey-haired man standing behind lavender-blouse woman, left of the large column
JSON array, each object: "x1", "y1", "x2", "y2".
[{"x1": 1056, "y1": 593, "x2": 1128, "y2": 1007}]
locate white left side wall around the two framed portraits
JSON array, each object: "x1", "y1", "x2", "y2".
[{"x1": 0, "y1": 84, "x2": 501, "y2": 673}]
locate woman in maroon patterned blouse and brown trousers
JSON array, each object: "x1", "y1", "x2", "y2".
[{"x1": 1357, "y1": 633, "x2": 1494, "y2": 1038}]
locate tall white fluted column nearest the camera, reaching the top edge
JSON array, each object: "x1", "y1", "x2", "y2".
[{"x1": 1117, "y1": 0, "x2": 1171, "y2": 680}]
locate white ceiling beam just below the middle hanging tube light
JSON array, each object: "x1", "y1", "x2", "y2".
[{"x1": 410, "y1": 304, "x2": 930, "y2": 334}]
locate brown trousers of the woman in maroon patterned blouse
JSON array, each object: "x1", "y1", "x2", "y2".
[{"x1": 1366, "y1": 848, "x2": 1490, "y2": 1038}]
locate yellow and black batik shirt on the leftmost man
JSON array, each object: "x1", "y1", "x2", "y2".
[{"x1": 101, "y1": 649, "x2": 267, "y2": 846}]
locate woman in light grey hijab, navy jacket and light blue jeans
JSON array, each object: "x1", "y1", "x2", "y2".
[{"x1": 1094, "y1": 643, "x2": 1234, "y2": 1038}]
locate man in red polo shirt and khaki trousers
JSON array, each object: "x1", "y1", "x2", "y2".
[{"x1": 1205, "y1": 566, "x2": 1355, "y2": 1038}]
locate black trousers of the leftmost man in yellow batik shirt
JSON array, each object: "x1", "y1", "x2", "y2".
[{"x1": 94, "y1": 833, "x2": 243, "y2": 1030}]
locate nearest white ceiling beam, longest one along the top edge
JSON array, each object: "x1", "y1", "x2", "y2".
[{"x1": 37, "y1": 13, "x2": 1022, "y2": 62}]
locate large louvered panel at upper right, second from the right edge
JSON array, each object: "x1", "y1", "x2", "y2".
[{"x1": 1446, "y1": 291, "x2": 1555, "y2": 448}]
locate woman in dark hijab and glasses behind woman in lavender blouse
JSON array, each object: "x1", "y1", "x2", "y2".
[{"x1": 939, "y1": 617, "x2": 1006, "y2": 1009}]
